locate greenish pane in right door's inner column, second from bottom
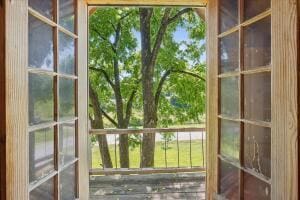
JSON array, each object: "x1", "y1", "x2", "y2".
[{"x1": 221, "y1": 120, "x2": 240, "y2": 160}]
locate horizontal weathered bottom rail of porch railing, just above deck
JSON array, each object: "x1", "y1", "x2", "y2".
[{"x1": 90, "y1": 167, "x2": 205, "y2": 176}]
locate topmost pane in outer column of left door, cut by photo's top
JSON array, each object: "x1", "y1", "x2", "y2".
[{"x1": 28, "y1": 0, "x2": 53, "y2": 19}]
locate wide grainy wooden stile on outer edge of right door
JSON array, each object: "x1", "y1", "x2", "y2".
[{"x1": 271, "y1": 0, "x2": 299, "y2": 200}]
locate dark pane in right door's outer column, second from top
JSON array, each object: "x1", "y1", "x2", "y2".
[{"x1": 244, "y1": 17, "x2": 271, "y2": 70}]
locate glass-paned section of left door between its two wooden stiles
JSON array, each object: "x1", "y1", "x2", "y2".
[{"x1": 28, "y1": 0, "x2": 78, "y2": 200}]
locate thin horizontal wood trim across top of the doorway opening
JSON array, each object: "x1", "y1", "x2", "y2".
[{"x1": 85, "y1": 0, "x2": 208, "y2": 6}]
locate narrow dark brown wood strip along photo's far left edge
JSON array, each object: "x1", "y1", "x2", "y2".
[{"x1": 0, "y1": 1, "x2": 6, "y2": 199}]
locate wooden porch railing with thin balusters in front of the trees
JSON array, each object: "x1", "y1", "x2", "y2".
[{"x1": 90, "y1": 128, "x2": 206, "y2": 175}]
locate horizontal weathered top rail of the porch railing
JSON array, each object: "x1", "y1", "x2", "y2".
[{"x1": 89, "y1": 128, "x2": 205, "y2": 135}]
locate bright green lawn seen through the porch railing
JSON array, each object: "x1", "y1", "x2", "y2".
[{"x1": 92, "y1": 140, "x2": 205, "y2": 168}]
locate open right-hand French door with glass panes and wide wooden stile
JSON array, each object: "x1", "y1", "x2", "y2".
[{"x1": 207, "y1": 0, "x2": 298, "y2": 200}]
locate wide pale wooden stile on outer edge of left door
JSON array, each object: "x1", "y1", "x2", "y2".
[{"x1": 5, "y1": 0, "x2": 28, "y2": 200}]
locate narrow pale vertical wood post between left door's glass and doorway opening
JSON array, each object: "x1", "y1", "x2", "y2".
[{"x1": 77, "y1": 0, "x2": 89, "y2": 200}]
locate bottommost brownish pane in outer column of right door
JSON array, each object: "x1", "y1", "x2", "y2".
[{"x1": 244, "y1": 173, "x2": 271, "y2": 200}]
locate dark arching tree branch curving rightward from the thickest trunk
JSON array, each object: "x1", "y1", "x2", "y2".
[{"x1": 155, "y1": 69, "x2": 205, "y2": 108}]
